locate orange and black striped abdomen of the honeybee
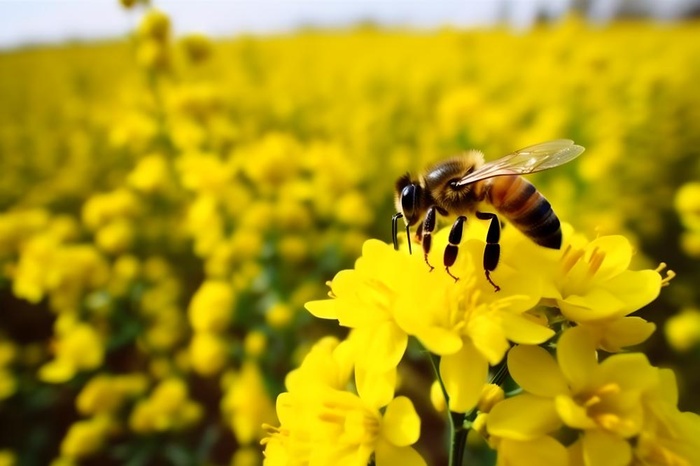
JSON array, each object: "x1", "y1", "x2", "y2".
[{"x1": 489, "y1": 176, "x2": 562, "y2": 249}]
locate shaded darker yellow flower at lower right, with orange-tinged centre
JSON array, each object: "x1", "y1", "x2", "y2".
[{"x1": 487, "y1": 327, "x2": 690, "y2": 466}]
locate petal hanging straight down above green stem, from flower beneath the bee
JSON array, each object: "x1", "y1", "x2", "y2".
[{"x1": 440, "y1": 342, "x2": 489, "y2": 413}]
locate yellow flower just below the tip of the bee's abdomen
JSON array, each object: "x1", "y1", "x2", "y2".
[{"x1": 505, "y1": 225, "x2": 663, "y2": 352}]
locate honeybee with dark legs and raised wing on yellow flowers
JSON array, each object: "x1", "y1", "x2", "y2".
[{"x1": 392, "y1": 139, "x2": 584, "y2": 291}]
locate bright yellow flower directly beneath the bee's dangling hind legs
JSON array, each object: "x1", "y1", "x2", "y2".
[{"x1": 395, "y1": 229, "x2": 554, "y2": 412}]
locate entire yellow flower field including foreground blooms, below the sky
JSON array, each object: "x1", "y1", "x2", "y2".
[{"x1": 0, "y1": 2, "x2": 700, "y2": 466}]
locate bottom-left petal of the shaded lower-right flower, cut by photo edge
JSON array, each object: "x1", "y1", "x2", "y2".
[{"x1": 498, "y1": 436, "x2": 568, "y2": 466}]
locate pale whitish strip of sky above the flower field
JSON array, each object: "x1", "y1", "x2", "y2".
[{"x1": 0, "y1": 0, "x2": 700, "y2": 48}]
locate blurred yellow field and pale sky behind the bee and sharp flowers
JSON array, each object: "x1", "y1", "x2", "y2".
[{"x1": 0, "y1": 0, "x2": 700, "y2": 466}]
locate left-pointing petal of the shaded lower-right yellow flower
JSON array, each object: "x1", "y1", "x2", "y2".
[{"x1": 486, "y1": 393, "x2": 561, "y2": 441}]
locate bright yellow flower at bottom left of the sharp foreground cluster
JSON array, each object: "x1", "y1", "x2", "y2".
[{"x1": 263, "y1": 339, "x2": 426, "y2": 466}]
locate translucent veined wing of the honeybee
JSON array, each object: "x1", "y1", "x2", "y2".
[{"x1": 457, "y1": 139, "x2": 585, "y2": 186}]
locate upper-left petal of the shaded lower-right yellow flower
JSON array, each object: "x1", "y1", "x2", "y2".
[{"x1": 508, "y1": 345, "x2": 569, "y2": 397}]
